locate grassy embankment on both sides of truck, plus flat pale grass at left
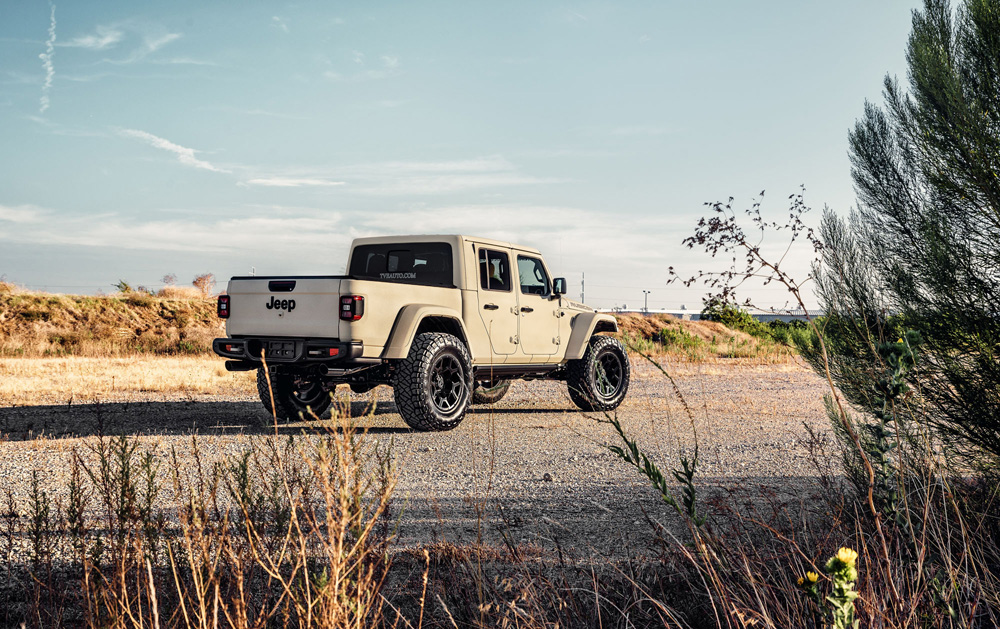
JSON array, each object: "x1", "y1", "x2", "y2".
[{"x1": 0, "y1": 282, "x2": 808, "y2": 405}]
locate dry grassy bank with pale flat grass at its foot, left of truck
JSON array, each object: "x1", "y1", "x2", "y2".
[{"x1": 0, "y1": 282, "x2": 253, "y2": 406}]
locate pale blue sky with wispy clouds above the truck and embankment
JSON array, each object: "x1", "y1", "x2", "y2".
[{"x1": 0, "y1": 0, "x2": 918, "y2": 310}]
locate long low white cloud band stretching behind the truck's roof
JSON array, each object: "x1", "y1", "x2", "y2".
[{"x1": 0, "y1": 204, "x2": 687, "y2": 277}]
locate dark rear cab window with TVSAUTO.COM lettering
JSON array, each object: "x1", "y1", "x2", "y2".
[{"x1": 350, "y1": 242, "x2": 455, "y2": 286}]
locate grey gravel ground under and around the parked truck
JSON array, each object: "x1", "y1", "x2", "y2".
[{"x1": 0, "y1": 362, "x2": 827, "y2": 556}]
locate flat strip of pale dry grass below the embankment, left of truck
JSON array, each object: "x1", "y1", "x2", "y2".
[{"x1": 0, "y1": 356, "x2": 257, "y2": 406}]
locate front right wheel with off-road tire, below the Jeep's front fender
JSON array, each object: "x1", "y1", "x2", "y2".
[{"x1": 566, "y1": 336, "x2": 631, "y2": 411}]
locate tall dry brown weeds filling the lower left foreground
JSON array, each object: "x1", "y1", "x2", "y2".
[{"x1": 0, "y1": 415, "x2": 396, "y2": 629}]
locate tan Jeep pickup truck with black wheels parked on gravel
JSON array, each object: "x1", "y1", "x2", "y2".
[{"x1": 212, "y1": 236, "x2": 630, "y2": 430}]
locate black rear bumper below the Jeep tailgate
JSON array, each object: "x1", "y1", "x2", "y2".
[{"x1": 212, "y1": 337, "x2": 364, "y2": 365}]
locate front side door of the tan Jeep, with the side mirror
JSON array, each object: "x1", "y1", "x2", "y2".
[{"x1": 517, "y1": 254, "x2": 561, "y2": 362}]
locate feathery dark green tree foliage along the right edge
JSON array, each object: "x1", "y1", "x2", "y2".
[{"x1": 811, "y1": 0, "x2": 1000, "y2": 461}]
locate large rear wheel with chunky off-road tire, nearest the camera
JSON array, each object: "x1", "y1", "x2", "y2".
[{"x1": 392, "y1": 332, "x2": 473, "y2": 431}]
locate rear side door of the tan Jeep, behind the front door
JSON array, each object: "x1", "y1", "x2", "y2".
[{"x1": 477, "y1": 247, "x2": 518, "y2": 356}]
